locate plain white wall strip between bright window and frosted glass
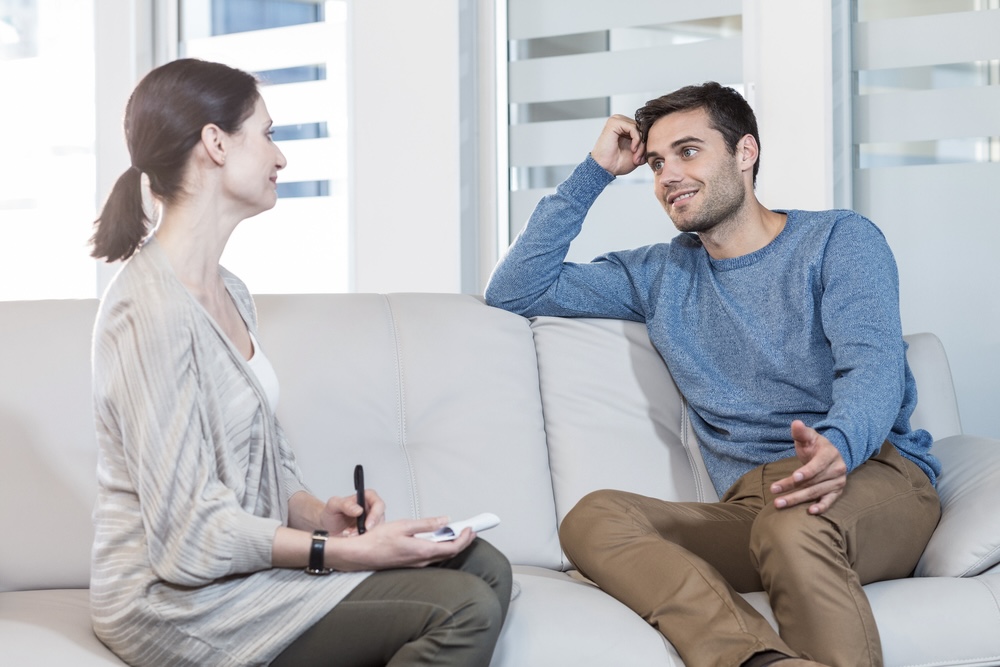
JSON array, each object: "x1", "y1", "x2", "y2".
[{"x1": 348, "y1": 0, "x2": 461, "y2": 292}]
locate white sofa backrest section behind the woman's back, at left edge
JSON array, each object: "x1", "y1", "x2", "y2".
[{"x1": 0, "y1": 299, "x2": 97, "y2": 591}]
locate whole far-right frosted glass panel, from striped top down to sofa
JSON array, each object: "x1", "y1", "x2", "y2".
[{"x1": 853, "y1": 0, "x2": 1000, "y2": 432}]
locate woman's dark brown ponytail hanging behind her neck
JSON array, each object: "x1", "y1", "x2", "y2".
[{"x1": 90, "y1": 166, "x2": 150, "y2": 262}]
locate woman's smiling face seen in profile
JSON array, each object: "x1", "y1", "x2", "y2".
[{"x1": 224, "y1": 97, "x2": 287, "y2": 218}]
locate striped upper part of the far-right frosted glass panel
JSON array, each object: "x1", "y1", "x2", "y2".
[{"x1": 854, "y1": 8, "x2": 1000, "y2": 169}]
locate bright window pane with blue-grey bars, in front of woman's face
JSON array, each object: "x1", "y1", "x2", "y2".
[{"x1": 178, "y1": 0, "x2": 352, "y2": 293}]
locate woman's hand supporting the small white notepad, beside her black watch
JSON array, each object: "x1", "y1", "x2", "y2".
[{"x1": 325, "y1": 520, "x2": 476, "y2": 572}]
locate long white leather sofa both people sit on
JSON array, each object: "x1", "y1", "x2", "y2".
[{"x1": 0, "y1": 294, "x2": 1000, "y2": 667}]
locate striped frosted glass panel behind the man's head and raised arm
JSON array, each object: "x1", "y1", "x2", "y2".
[{"x1": 507, "y1": 0, "x2": 743, "y2": 261}]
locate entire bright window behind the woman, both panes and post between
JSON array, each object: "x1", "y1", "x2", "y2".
[{"x1": 0, "y1": 0, "x2": 353, "y2": 300}]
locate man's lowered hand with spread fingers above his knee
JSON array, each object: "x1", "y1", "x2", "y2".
[{"x1": 771, "y1": 419, "x2": 847, "y2": 514}]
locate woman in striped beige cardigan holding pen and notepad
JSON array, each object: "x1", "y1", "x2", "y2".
[{"x1": 91, "y1": 59, "x2": 511, "y2": 666}]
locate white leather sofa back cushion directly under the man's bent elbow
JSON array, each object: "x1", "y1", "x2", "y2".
[{"x1": 532, "y1": 317, "x2": 718, "y2": 536}]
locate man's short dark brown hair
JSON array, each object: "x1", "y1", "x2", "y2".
[{"x1": 635, "y1": 81, "x2": 760, "y2": 185}]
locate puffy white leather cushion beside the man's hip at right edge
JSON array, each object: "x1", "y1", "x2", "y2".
[{"x1": 916, "y1": 435, "x2": 1000, "y2": 577}]
